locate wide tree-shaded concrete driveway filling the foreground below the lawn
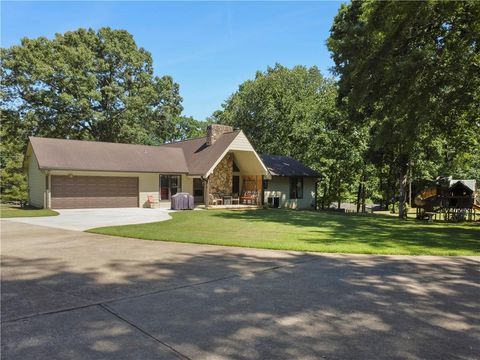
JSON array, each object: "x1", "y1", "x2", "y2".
[{"x1": 1, "y1": 222, "x2": 480, "y2": 360}]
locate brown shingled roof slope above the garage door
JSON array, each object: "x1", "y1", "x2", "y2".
[{"x1": 29, "y1": 137, "x2": 188, "y2": 173}]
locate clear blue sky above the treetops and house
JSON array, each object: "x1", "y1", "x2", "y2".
[{"x1": 1, "y1": 1, "x2": 340, "y2": 120}]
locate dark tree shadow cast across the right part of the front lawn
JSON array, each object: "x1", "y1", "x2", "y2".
[{"x1": 213, "y1": 210, "x2": 480, "y2": 254}]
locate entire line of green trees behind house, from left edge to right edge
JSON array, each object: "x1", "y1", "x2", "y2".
[{"x1": 0, "y1": 1, "x2": 480, "y2": 216}]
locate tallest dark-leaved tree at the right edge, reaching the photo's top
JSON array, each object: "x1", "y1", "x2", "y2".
[{"x1": 328, "y1": 1, "x2": 480, "y2": 216}]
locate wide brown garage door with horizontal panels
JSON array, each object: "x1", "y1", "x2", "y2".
[{"x1": 51, "y1": 175, "x2": 138, "y2": 209}]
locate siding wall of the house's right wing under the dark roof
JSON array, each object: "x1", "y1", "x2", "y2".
[{"x1": 265, "y1": 176, "x2": 315, "y2": 209}]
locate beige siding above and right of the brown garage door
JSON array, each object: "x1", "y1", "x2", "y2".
[{"x1": 51, "y1": 170, "x2": 160, "y2": 207}]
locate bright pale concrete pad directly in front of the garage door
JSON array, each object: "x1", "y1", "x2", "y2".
[{"x1": 2, "y1": 208, "x2": 171, "y2": 231}]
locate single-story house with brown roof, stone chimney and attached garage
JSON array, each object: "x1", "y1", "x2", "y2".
[{"x1": 24, "y1": 124, "x2": 319, "y2": 209}]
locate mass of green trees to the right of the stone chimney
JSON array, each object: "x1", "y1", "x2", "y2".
[{"x1": 215, "y1": 1, "x2": 480, "y2": 216}]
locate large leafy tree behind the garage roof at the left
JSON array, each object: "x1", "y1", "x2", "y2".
[{"x1": 0, "y1": 28, "x2": 182, "y2": 200}]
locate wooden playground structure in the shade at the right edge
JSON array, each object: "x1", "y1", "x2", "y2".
[{"x1": 415, "y1": 177, "x2": 480, "y2": 221}]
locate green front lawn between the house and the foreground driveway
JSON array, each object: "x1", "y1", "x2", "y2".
[{"x1": 89, "y1": 210, "x2": 480, "y2": 255}]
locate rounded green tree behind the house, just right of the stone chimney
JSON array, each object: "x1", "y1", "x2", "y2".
[{"x1": 213, "y1": 64, "x2": 363, "y2": 206}]
